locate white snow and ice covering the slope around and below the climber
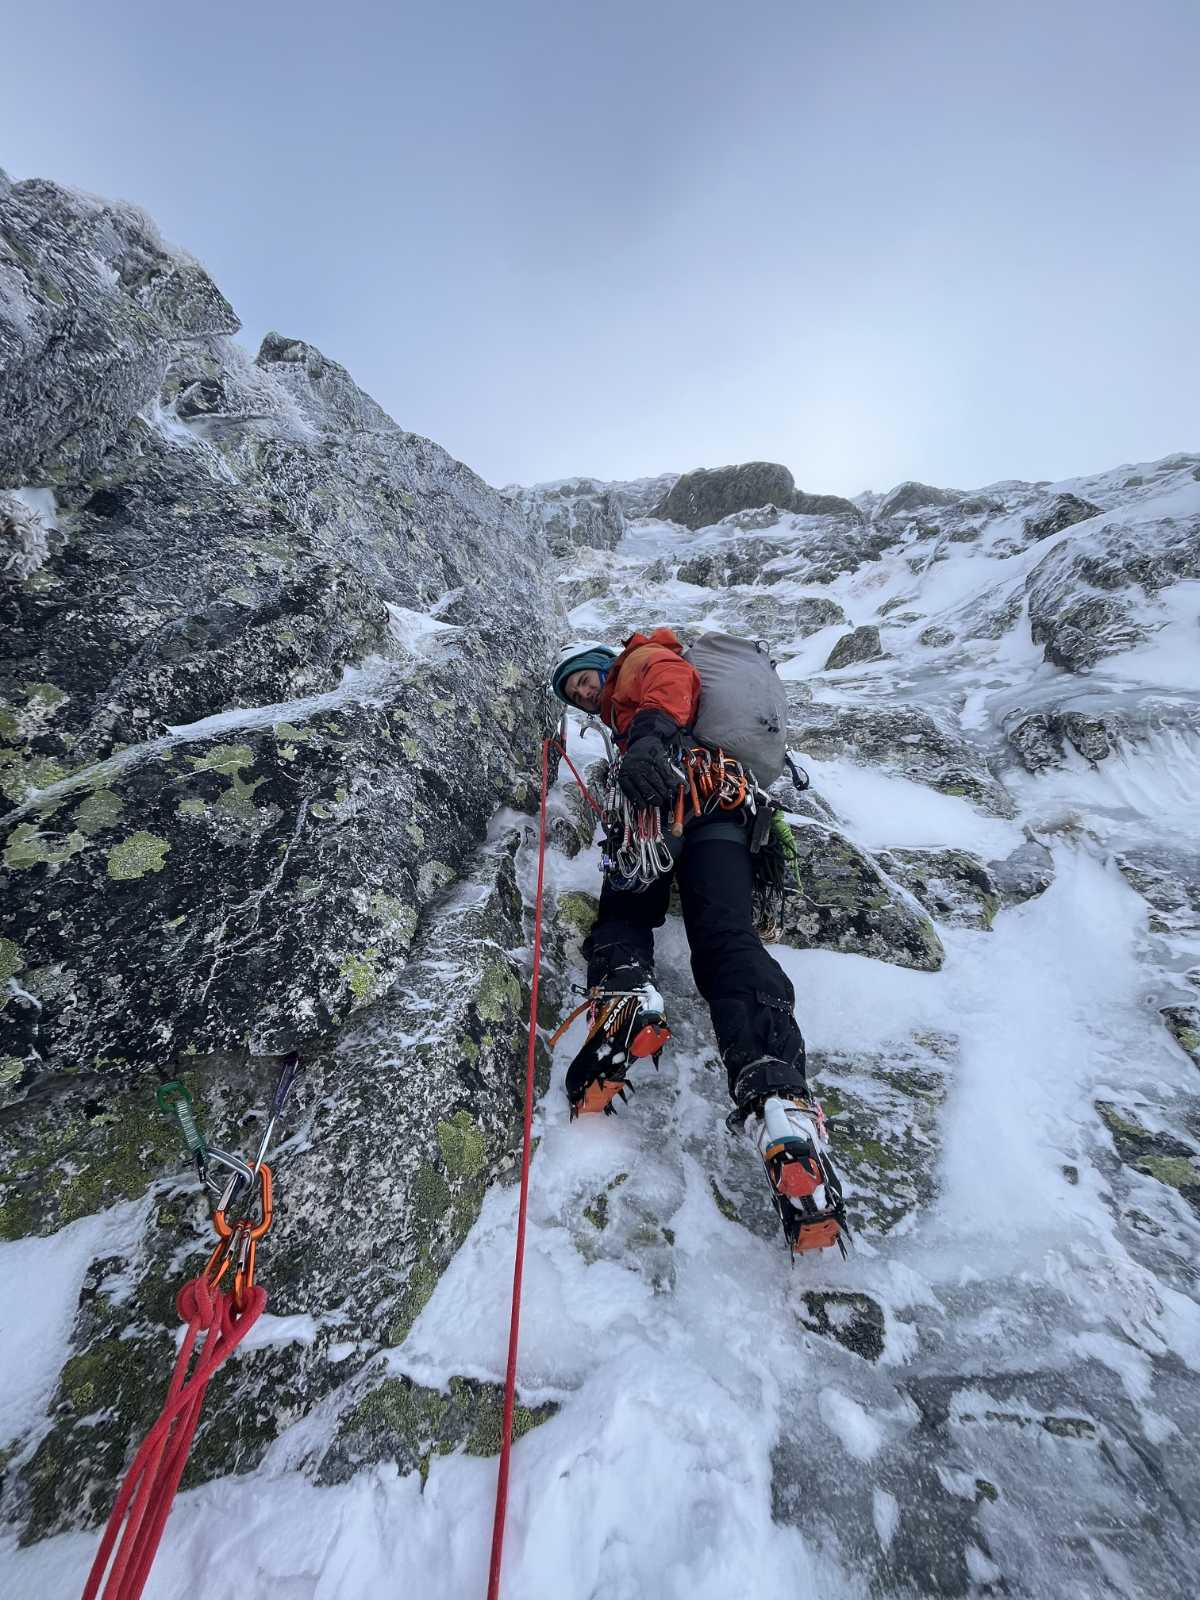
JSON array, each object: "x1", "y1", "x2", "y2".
[{"x1": 0, "y1": 469, "x2": 1200, "y2": 1600}]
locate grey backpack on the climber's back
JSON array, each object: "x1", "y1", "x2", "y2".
[{"x1": 683, "y1": 634, "x2": 787, "y2": 787}]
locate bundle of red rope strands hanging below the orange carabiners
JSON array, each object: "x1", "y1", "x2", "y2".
[{"x1": 83, "y1": 1278, "x2": 267, "y2": 1600}]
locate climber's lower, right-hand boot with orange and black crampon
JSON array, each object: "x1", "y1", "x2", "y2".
[{"x1": 726, "y1": 1056, "x2": 850, "y2": 1259}]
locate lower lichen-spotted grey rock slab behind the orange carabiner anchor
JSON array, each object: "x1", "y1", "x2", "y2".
[{"x1": 0, "y1": 830, "x2": 534, "y2": 1539}]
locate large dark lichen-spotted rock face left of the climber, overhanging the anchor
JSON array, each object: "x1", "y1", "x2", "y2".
[{"x1": 0, "y1": 175, "x2": 552, "y2": 1086}]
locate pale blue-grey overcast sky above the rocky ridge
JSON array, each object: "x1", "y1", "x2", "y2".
[{"x1": 0, "y1": 0, "x2": 1200, "y2": 493}]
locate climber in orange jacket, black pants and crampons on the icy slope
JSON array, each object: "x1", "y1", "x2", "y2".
[{"x1": 550, "y1": 627, "x2": 845, "y2": 1250}]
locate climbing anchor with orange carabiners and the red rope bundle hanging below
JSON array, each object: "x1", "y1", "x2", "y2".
[{"x1": 83, "y1": 1054, "x2": 301, "y2": 1600}]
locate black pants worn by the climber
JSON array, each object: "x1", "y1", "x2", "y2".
[{"x1": 586, "y1": 816, "x2": 805, "y2": 1091}]
